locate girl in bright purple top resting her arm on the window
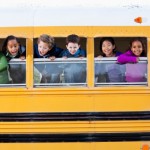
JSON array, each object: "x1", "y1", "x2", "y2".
[{"x1": 117, "y1": 38, "x2": 147, "y2": 82}]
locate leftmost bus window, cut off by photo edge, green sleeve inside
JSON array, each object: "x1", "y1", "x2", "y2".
[{"x1": 0, "y1": 37, "x2": 26, "y2": 87}]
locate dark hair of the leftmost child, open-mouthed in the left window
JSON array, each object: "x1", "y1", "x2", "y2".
[{"x1": 2, "y1": 35, "x2": 20, "y2": 52}]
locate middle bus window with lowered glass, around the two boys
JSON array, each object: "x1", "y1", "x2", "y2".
[{"x1": 34, "y1": 35, "x2": 87, "y2": 87}]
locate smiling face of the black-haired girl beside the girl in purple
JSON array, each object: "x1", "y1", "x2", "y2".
[{"x1": 102, "y1": 41, "x2": 115, "y2": 57}]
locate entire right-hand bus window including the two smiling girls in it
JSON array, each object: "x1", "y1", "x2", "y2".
[{"x1": 94, "y1": 37, "x2": 148, "y2": 86}]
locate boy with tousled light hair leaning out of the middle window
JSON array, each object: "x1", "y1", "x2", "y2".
[{"x1": 34, "y1": 34, "x2": 63, "y2": 83}]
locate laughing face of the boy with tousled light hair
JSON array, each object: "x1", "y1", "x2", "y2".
[{"x1": 38, "y1": 41, "x2": 50, "y2": 56}]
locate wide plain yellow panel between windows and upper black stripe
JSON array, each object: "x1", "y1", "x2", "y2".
[{"x1": 0, "y1": 92, "x2": 150, "y2": 112}]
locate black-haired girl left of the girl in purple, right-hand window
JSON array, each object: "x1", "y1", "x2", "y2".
[{"x1": 95, "y1": 37, "x2": 124, "y2": 83}]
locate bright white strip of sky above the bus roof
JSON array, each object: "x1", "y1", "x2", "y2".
[{"x1": 0, "y1": 0, "x2": 150, "y2": 8}]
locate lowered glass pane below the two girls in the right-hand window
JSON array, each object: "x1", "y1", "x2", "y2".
[{"x1": 95, "y1": 58, "x2": 147, "y2": 86}]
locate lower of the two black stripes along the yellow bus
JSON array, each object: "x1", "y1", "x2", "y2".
[{"x1": 0, "y1": 132, "x2": 150, "y2": 143}]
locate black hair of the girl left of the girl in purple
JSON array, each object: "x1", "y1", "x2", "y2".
[{"x1": 100, "y1": 37, "x2": 116, "y2": 57}]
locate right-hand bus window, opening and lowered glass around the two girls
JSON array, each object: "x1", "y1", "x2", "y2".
[{"x1": 94, "y1": 37, "x2": 148, "y2": 86}]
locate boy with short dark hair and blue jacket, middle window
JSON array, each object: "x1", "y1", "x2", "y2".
[{"x1": 62, "y1": 34, "x2": 86, "y2": 83}]
